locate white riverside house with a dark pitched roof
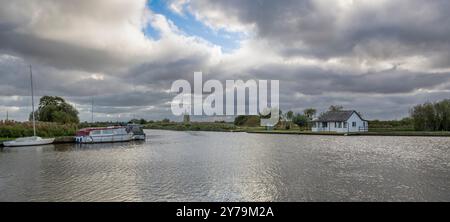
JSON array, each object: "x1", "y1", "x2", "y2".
[{"x1": 311, "y1": 110, "x2": 369, "y2": 133}]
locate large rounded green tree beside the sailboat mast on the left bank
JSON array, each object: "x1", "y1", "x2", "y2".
[{"x1": 30, "y1": 96, "x2": 80, "y2": 124}]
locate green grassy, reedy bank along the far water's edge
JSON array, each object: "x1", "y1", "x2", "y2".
[{"x1": 0, "y1": 121, "x2": 450, "y2": 143}]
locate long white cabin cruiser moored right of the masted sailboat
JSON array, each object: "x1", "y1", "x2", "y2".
[{"x1": 75, "y1": 126, "x2": 133, "y2": 143}]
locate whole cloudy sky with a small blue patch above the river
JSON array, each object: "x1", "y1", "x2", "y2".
[{"x1": 0, "y1": 0, "x2": 450, "y2": 121}]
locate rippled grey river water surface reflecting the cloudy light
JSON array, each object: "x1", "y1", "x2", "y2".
[{"x1": 0, "y1": 130, "x2": 450, "y2": 201}]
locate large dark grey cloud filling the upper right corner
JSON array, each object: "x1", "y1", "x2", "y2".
[{"x1": 190, "y1": 0, "x2": 450, "y2": 60}]
